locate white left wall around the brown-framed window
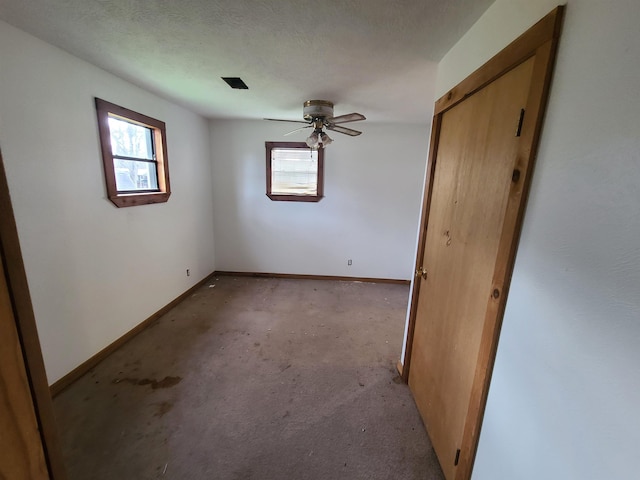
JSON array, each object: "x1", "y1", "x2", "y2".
[{"x1": 0, "y1": 22, "x2": 215, "y2": 382}]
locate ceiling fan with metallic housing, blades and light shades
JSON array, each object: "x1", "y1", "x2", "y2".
[{"x1": 265, "y1": 100, "x2": 366, "y2": 149}]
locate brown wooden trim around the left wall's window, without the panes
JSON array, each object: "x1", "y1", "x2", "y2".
[{"x1": 95, "y1": 98, "x2": 171, "y2": 208}]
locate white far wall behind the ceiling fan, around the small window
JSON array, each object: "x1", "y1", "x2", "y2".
[{"x1": 211, "y1": 117, "x2": 429, "y2": 279}]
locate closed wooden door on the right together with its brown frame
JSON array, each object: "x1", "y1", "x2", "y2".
[{"x1": 403, "y1": 9, "x2": 562, "y2": 480}]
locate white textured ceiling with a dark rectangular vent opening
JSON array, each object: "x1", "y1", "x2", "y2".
[{"x1": 0, "y1": 0, "x2": 493, "y2": 123}]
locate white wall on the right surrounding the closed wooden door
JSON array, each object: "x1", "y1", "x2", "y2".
[{"x1": 437, "y1": 0, "x2": 640, "y2": 480}]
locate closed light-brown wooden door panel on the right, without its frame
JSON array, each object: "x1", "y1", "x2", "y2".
[{"x1": 409, "y1": 59, "x2": 533, "y2": 478}]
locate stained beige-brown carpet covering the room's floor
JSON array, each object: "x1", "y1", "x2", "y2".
[{"x1": 54, "y1": 276, "x2": 443, "y2": 480}]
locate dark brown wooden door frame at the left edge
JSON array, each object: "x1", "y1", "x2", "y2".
[{"x1": 0, "y1": 148, "x2": 66, "y2": 480}]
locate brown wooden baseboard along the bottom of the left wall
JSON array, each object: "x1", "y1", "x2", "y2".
[{"x1": 49, "y1": 273, "x2": 214, "y2": 397}]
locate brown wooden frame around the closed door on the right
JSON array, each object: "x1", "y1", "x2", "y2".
[{"x1": 401, "y1": 6, "x2": 565, "y2": 480}]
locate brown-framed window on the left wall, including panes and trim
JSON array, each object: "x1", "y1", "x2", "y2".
[{"x1": 96, "y1": 98, "x2": 171, "y2": 207}]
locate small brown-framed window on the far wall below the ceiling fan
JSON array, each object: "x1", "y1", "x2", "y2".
[{"x1": 265, "y1": 142, "x2": 324, "y2": 202}]
